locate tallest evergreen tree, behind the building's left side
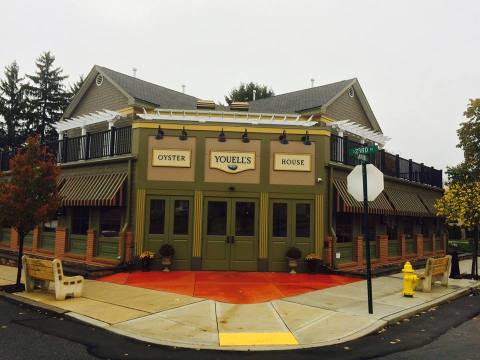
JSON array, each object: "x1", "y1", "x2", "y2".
[{"x1": 27, "y1": 51, "x2": 69, "y2": 141}]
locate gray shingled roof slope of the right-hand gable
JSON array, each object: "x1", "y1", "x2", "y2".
[{"x1": 250, "y1": 79, "x2": 356, "y2": 114}]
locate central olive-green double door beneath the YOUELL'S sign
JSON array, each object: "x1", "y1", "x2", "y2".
[{"x1": 203, "y1": 198, "x2": 258, "y2": 271}]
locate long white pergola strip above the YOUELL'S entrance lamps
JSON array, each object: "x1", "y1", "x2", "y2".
[{"x1": 137, "y1": 109, "x2": 317, "y2": 127}]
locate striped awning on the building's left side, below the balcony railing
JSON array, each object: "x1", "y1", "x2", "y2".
[{"x1": 59, "y1": 172, "x2": 127, "y2": 206}]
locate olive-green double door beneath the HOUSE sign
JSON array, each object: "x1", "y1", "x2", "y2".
[{"x1": 269, "y1": 199, "x2": 315, "y2": 271}]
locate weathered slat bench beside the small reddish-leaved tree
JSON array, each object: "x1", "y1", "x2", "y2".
[{"x1": 22, "y1": 255, "x2": 84, "y2": 300}]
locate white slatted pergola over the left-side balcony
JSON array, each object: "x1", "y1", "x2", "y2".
[{"x1": 54, "y1": 109, "x2": 123, "y2": 139}]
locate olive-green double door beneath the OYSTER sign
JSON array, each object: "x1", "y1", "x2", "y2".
[{"x1": 144, "y1": 196, "x2": 192, "y2": 269}]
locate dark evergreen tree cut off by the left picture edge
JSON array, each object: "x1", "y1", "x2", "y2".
[{"x1": 0, "y1": 61, "x2": 27, "y2": 147}]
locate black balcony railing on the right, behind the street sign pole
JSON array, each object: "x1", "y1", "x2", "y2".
[{"x1": 330, "y1": 134, "x2": 442, "y2": 188}]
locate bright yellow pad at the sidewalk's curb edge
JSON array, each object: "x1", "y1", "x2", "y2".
[{"x1": 218, "y1": 332, "x2": 298, "y2": 346}]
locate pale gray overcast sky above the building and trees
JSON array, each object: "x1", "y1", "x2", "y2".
[{"x1": 0, "y1": 0, "x2": 480, "y2": 172}]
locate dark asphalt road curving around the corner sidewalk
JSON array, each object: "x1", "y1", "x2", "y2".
[{"x1": 0, "y1": 296, "x2": 480, "y2": 360}]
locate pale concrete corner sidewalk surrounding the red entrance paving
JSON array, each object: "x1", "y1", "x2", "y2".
[{"x1": 0, "y1": 260, "x2": 480, "y2": 350}]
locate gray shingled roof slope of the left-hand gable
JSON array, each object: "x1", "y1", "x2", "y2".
[{"x1": 97, "y1": 65, "x2": 201, "y2": 110}]
